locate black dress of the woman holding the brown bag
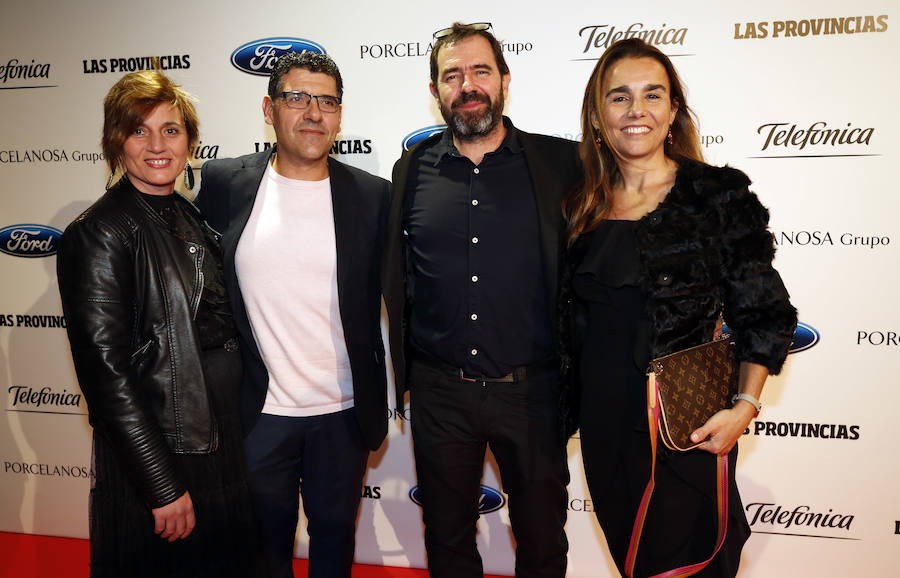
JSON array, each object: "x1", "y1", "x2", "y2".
[{"x1": 572, "y1": 220, "x2": 750, "y2": 576}]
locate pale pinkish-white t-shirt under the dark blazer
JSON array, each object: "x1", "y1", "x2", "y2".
[{"x1": 235, "y1": 164, "x2": 353, "y2": 416}]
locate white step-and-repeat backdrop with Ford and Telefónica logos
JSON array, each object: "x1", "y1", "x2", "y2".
[{"x1": 0, "y1": 0, "x2": 900, "y2": 577}]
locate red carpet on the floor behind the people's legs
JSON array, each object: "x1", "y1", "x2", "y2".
[{"x1": 0, "y1": 532, "x2": 501, "y2": 578}]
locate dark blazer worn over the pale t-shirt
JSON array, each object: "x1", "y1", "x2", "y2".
[{"x1": 194, "y1": 148, "x2": 391, "y2": 450}]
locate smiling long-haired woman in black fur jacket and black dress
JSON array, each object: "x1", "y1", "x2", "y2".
[{"x1": 561, "y1": 38, "x2": 797, "y2": 576}]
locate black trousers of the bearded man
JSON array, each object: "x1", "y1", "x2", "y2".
[{"x1": 409, "y1": 360, "x2": 569, "y2": 578}]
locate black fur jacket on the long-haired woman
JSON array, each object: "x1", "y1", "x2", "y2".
[{"x1": 560, "y1": 161, "x2": 797, "y2": 436}]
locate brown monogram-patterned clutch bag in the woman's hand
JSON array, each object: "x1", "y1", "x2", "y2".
[{"x1": 652, "y1": 336, "x2": 738, "y2": 450}]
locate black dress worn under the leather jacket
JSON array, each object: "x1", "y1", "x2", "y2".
[{"x1": 90, "y1": 194, "x2": 263, "y2": 578}]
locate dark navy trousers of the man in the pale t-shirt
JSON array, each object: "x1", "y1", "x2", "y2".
[{"x1": 244, "y1": 408, "x2": 369, "y2": 578}]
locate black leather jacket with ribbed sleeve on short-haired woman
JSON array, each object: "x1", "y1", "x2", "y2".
[{"x1": 57, "y1": 177, "x2": 218, "y2": 508}]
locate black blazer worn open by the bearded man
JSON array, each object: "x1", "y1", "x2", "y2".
[{"x1": 382, "y1": 128, "x2": 582, "y2": 407}]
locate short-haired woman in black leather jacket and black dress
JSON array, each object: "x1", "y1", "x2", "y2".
[{"x1": 57, "y1": 71, "x2": 256, "y2": 578}]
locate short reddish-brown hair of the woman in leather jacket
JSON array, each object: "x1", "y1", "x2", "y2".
[{"x1": 100, "y1": 70, "x2": 200, "y2": 174}]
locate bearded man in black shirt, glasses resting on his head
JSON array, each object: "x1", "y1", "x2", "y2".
[{"x1": 383, "y1": 23, "x2": 581, "y2": 578}]
